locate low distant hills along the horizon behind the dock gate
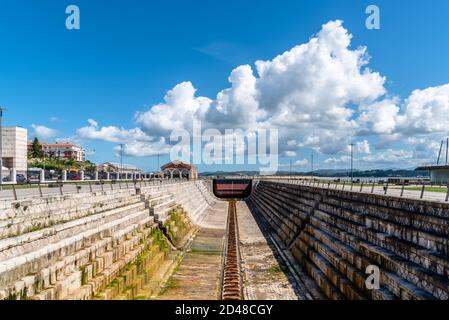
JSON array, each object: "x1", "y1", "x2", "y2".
[{"x1": 200, "y1": 169, "x2": 430, "y2": 178}]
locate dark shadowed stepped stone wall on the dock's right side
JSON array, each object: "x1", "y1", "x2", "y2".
[{"x1": 248, "y1": 181, "x2": 449, "y2": 300}]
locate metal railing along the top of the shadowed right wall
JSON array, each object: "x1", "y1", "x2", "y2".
[{"x1": 268, "y1": 179, "x2": 449, "y2": 202}]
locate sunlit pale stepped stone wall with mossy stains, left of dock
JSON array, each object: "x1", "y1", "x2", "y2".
[{"x1": 0, "y1": 182, "x2": 214, "y2": 300}]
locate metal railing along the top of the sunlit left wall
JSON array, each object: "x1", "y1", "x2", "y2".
[{"x1": 0, "y1": 179, "x2": 189, "y2": 200}]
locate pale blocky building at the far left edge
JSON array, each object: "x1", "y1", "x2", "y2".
[{"x1": 1, "y1": 127, "x2": 28, "y2": 173}]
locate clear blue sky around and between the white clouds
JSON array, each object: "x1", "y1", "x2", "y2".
[{"x1": 0, "y1": 0, "x2": 449, "y2": 171}]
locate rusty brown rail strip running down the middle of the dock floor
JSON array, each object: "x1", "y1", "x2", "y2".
[{"x1": 222, "y1": 201, "x2": 243, "y2": 300}]
